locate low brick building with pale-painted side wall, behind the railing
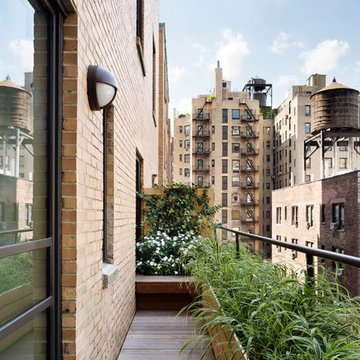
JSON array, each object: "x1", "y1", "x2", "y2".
[{"x1": 272, "y1": 170, "x2": 360, "y2": 296}]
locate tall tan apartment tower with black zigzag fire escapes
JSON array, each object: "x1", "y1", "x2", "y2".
[{"x1": 192, "y1": 66, "x2": 273, "y2": 245}]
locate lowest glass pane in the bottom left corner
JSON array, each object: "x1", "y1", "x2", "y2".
[{"x1": 0, "y1": 313, "x2": 47, "y2": 360}]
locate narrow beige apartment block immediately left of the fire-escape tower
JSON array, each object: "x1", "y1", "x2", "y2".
[{"x1": 173, "y1": 109, "x2": 193, "y2": 186}]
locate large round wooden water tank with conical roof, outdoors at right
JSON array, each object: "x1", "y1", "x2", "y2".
[{"x1": 311, "y1": 78, "x2": 359, "y2": 134}]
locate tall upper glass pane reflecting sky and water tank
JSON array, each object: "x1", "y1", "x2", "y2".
[{"x1": 0, "y1": 0, "x2": 47, "y2": 246}]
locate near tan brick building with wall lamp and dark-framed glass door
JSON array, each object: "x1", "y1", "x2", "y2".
[{"x1": 0, "y1": 0, "x2": 171, "y2": 360}]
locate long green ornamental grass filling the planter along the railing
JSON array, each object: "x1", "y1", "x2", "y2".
[{"x1": 185, "y1": 239, "x2": 360, "y2": 360}]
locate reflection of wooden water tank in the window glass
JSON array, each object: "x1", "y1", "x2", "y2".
[{"x1": 0, "y1": 77, "x2": 32, "y2": 132}]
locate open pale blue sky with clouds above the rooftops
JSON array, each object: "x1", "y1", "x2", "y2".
[{"x1": 159, "y1": 0, "x2": 360, "y2": 117}]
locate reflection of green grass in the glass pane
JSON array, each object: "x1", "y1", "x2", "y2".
[{"x1": 0, "y1": 253, "x2": 33, "y2": 294}]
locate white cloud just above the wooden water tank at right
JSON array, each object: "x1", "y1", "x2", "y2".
[{"x1": 300, "y1": 40, "x2": 350, "y2": 75}]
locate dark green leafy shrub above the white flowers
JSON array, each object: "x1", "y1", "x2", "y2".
[{"x1": 138, "y1": 183, "x2": 218, "y2": 237}]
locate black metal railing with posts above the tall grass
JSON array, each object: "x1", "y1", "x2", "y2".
[{"x1": 215, "y1": 226, "x2": 360, "y2": 281}]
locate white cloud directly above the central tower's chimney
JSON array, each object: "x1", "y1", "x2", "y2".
[{"x1": 212, "y1": 29, "x2": 250, "y2": 79}]
